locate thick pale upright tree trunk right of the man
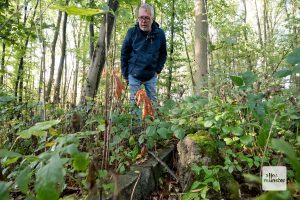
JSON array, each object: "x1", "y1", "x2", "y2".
[{"x1": 195, "y1": 0, "x2": 208, "y2": 95}]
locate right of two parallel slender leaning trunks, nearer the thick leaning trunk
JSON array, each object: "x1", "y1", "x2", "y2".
[{"x1": 53, "y1": 0, "x2": 69, "y2": 103}]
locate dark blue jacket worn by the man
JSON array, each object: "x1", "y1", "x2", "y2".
[{"x1": 121, "y1": 21, "x2": 167, "y2": 81}]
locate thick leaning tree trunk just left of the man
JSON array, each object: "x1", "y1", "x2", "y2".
[{"x1": 80, "y1": 0, "x2": 119, "y2": 104}]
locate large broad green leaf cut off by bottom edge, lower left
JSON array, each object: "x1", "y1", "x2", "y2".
[{"x1": 35, "y1": 155, "x2": 65, "y2": 200}]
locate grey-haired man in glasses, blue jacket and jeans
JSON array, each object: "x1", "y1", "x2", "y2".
[{"x1": 121, "y1": 4, "x2": 167, "y2": 130}]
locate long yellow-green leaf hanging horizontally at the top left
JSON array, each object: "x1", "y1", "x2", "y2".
[{"x1": 51, "y1": 5, "x2": 106, "y2": 16}]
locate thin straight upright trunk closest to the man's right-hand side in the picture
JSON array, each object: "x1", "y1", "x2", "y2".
[{"x1": 167, "y1": 0, "x2": 175, "y2": 99}]
